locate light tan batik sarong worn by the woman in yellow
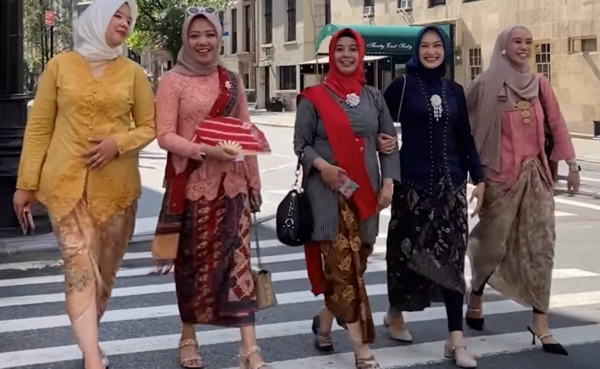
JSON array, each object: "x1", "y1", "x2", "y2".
[{"x1": 50, "y1": 196, "x2": 137, "y2": 321}]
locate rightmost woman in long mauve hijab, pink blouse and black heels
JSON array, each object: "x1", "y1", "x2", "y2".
[{"x1": 466, "y1": 26, "x2": 579, "y2": 355}]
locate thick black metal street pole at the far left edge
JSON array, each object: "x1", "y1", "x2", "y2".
[{"x1": 0, "y1": 0, "x2": 50, "y2": 237}]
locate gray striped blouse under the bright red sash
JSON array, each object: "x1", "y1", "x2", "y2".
[{"x1": 294, "y1": 87, "x2": 400, "y2": 244}]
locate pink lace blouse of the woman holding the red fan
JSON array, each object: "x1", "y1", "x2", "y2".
[{"x1": 156, "y1": 72, "x2": 261, "y2": 201}]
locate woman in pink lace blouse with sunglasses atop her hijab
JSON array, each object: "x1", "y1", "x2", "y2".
[{"x1": 153, "y1": 8, "x2": 268, "y2": 369}]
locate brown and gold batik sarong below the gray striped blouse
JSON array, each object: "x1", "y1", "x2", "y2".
[{"x1": 320, "y1": 196, "x2": 375, "y2": 343}]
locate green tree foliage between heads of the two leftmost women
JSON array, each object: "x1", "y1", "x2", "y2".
[{"x1": 127, "y1": 0, "x2": 233, "y2": 60}]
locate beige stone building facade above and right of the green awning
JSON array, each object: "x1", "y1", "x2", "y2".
[{"x1": 321, "y1": 0, "x2": 600, "y2": 135}]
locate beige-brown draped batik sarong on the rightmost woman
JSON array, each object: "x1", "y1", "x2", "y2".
[{"x1": 468, "y1": 159, "x2": 556, "y2": 312}]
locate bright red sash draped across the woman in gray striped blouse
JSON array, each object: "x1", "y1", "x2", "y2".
[{"x1": 300, "y1": 85, "x2": 378, "y2": 296}]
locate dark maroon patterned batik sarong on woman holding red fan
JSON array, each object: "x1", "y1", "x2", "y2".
[{"x1": 174, "y1": 183, "x2": 258, "y2": 327}]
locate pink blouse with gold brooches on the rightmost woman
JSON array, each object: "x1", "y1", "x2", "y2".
[{"x1": 491, "y1": 77, "x2": 575, "y2": 186}]
